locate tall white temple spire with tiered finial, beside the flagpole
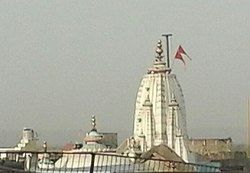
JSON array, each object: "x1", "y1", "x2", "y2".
[{"x1": 118, "y1": 34, "x2": 194, "y2": 162}]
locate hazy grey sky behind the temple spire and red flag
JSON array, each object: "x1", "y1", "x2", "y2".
[{"x1": 0, "y1": 0, "x2": 250, "y2": 146}]
